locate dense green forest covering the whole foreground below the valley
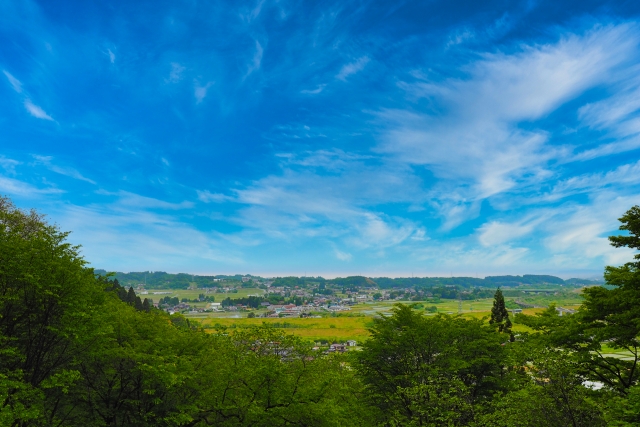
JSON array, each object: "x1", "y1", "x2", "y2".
[{"x1": 0, "y1": 199, "x2": 640, "y2": 427}]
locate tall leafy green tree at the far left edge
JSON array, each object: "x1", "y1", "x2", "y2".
[{"x1": 0, "y1": 198, "x2": 104, "y2": 425}]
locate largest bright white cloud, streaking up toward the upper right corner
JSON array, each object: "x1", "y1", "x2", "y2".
[{"x1": 375, "y1": 25, "x2": 638, "y2": 227}]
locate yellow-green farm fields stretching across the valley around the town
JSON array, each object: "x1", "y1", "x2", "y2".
[{"x1": 141, "y1": 280, "x2": 582, "y2": 342}]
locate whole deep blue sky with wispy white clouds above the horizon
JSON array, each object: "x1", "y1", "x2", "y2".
[{"x1": 0, "y1": 0, "x2": 640, "y2": 277}]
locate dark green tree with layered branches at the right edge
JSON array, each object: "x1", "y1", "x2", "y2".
[{"x1": 518, "y1": 206, "x2": 640, "y2": 396}]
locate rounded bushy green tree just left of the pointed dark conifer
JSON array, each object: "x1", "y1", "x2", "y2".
[{"x1": 355, "y1": 304, "x2": 507, "y2": 426}]
